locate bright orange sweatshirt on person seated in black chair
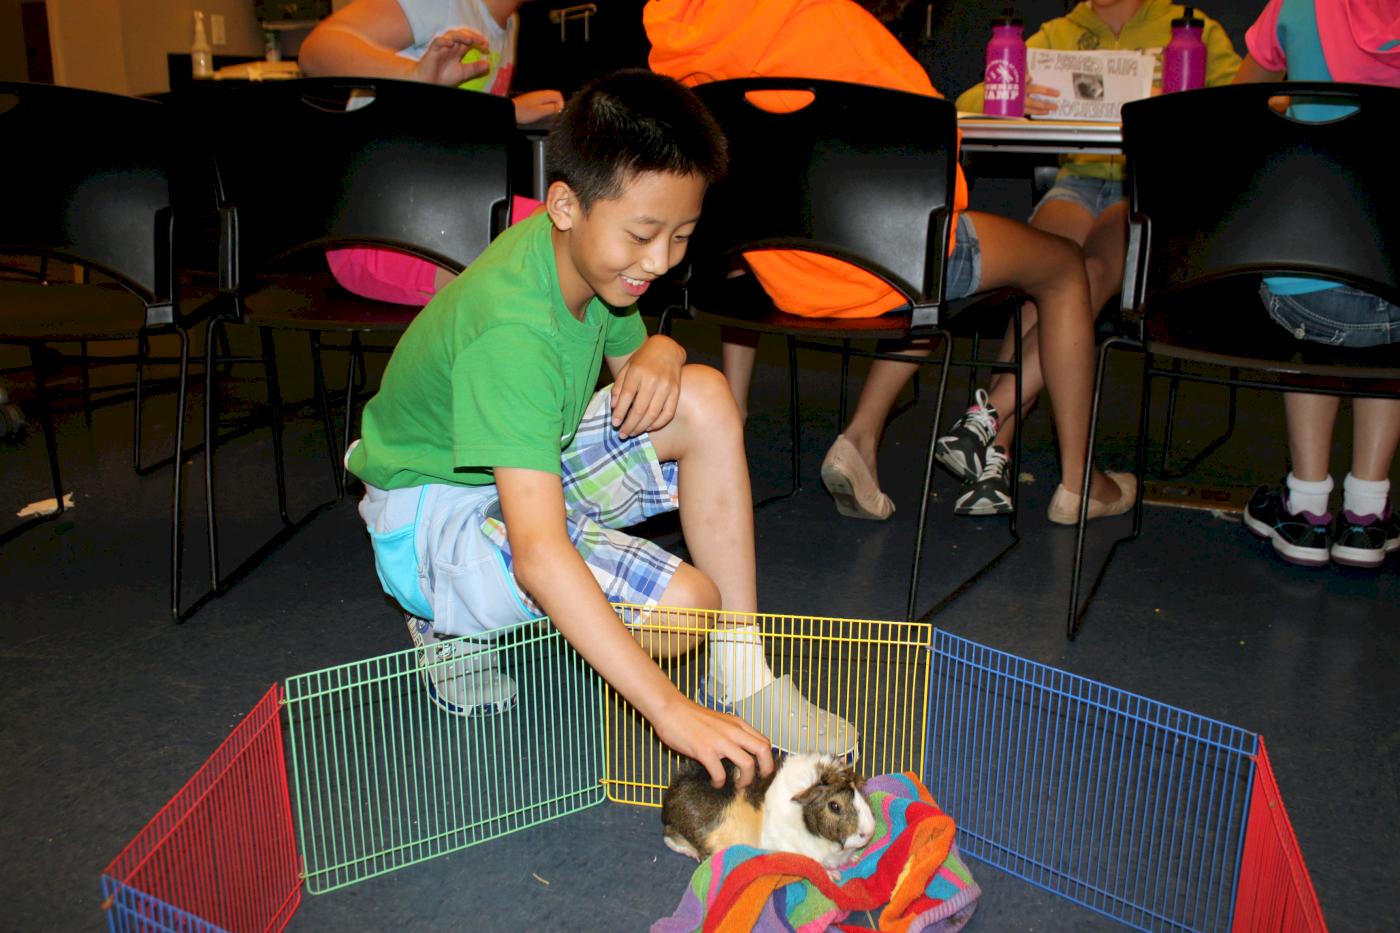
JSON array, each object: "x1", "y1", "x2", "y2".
[{"x1": 641, "y1": 0, "x2": 967, "y2": 318}]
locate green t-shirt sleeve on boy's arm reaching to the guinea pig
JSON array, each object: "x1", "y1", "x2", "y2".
[{"x1": 451, "y1": 325, "x2": 564, "y2": 474}]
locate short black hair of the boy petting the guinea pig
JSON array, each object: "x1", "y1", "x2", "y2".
[{"x1": 545, "y1": 69, "x2": 729, "y2": 212}]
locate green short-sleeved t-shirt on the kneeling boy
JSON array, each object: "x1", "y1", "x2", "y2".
[{"x1": 350, "y1": 212, "x2": 647, "y2": 489}]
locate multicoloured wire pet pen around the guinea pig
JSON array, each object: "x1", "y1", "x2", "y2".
[{"x1": 102, "y1": 607, "x2": 1326, "y2": 933}]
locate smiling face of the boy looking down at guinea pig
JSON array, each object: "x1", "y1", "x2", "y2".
[{"x1": 545, "y1": 165, "x2": 706, "y2": 313}]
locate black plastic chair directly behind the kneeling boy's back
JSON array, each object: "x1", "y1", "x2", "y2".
[{"x1": 195, "y1": 78, "x2": 524, "y2": 608}]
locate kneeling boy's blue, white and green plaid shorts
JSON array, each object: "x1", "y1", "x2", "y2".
[{"x1": 360, "y1": 389, "x2": 680, "y2": 635}]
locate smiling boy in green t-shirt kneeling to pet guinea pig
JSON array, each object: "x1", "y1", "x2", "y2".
[{"x1": 349, "y1": 71, "x2": 855, "y2": 785}]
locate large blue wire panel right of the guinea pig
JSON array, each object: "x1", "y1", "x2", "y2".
[{"x1": 925, "y1": 630, "x2": 1257, "y2": 930}]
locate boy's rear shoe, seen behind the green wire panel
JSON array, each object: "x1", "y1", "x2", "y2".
[{"x1": 405, "y1": 615, "x2": 517, "y2": 716}]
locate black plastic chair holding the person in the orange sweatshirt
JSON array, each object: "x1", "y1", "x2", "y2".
[{"x1": 680, "y1": 78, "x2": 1022, "y2": 618}]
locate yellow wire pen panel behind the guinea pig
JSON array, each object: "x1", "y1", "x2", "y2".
[{"x1": 602, "y1": 604, "x2": 934, "y2": 807}]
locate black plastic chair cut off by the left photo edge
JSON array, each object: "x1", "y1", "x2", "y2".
[{"x1": 0, "y1": 83, "x2": 209, "y2": 615}]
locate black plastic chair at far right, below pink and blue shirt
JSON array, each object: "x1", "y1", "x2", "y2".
[{"x1": 1067, "y1": 83, "x2": 1400, "y2": 639}]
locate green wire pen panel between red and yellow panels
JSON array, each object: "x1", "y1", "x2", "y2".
[{"x1": 286, "y1": 621, "x2": 605, "y2": 894}]
